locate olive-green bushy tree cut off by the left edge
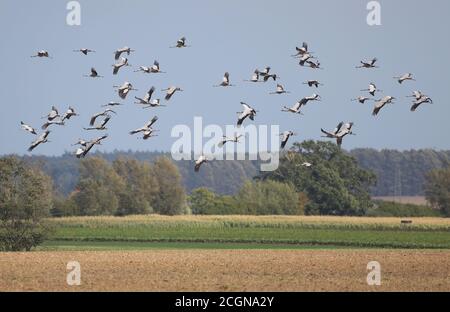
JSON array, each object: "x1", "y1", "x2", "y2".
[{"x1": 0, "y1": 157, "x2": 52, "y2": 251}]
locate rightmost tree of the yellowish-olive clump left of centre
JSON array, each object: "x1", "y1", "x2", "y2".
[{"x1": 153, "y1": 157, "x2": 187, "y2": 215}]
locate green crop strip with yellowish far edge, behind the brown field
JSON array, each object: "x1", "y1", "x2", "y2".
[{"x1": 43, "y1": 215, "x2": 450, "y2": 250}]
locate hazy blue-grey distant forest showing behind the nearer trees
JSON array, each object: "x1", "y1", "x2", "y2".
[{"x1": 14, "y1": 149, "x2": 450, "y2": 196}]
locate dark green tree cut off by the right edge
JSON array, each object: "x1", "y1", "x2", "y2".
[{"x1": 425, "y1": 167, "x2": 450, "y2": 217}]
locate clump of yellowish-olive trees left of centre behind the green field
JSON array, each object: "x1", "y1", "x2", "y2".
[{"x1": 51, "y1": 157, "x2": 186, "y2": 216}]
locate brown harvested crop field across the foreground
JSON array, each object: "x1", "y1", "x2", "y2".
[{"x1": 0, "y1": 249, "x2": 450, "y2": 291}]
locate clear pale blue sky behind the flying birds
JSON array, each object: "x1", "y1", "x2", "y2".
[{"x1": 0, "y1": 0, "x2": 450, "y2": 155}]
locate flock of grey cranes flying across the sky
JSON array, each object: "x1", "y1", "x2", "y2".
[{"x1": 21, "y1": 37, "x2": 433, "y2": 172}]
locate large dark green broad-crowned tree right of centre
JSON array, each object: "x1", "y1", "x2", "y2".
[{"x1": 259, "y1": 141, "x2": 376, "y2": 215}]
